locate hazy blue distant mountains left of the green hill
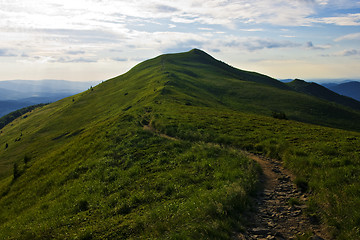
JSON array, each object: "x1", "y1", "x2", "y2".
[{"x1": 0, "y1": 80, "x2": 97, "y2": 117}]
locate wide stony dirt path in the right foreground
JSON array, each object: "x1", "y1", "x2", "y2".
[{"x1": 234, "y1": 153, "x2": 329, "y2": 240}]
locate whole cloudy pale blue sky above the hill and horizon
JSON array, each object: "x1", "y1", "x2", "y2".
[{"x1": 0, "y1": 0, "x2": 360, "y2": 81}]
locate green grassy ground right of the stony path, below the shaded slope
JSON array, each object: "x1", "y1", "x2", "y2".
[{"x1": 152, "y1": 103, "x2": 360, "y2": 239}]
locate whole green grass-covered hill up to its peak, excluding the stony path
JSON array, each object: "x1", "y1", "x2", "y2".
[{"x1": 0, "y1": 49, "x2": 360, "y2": 239}]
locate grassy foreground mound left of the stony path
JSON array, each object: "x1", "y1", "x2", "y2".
[{"x1": 0, "y1": 115, "x2": 259, "y2": 239}]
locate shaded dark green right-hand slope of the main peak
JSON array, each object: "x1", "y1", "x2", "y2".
[{"x1": 156, "y1": 51, "x2": 360, "y2": 131}]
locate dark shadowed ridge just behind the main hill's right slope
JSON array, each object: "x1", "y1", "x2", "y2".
[{"x1": 287, "y1": 79, "x2": 360, "y2": 110}]
